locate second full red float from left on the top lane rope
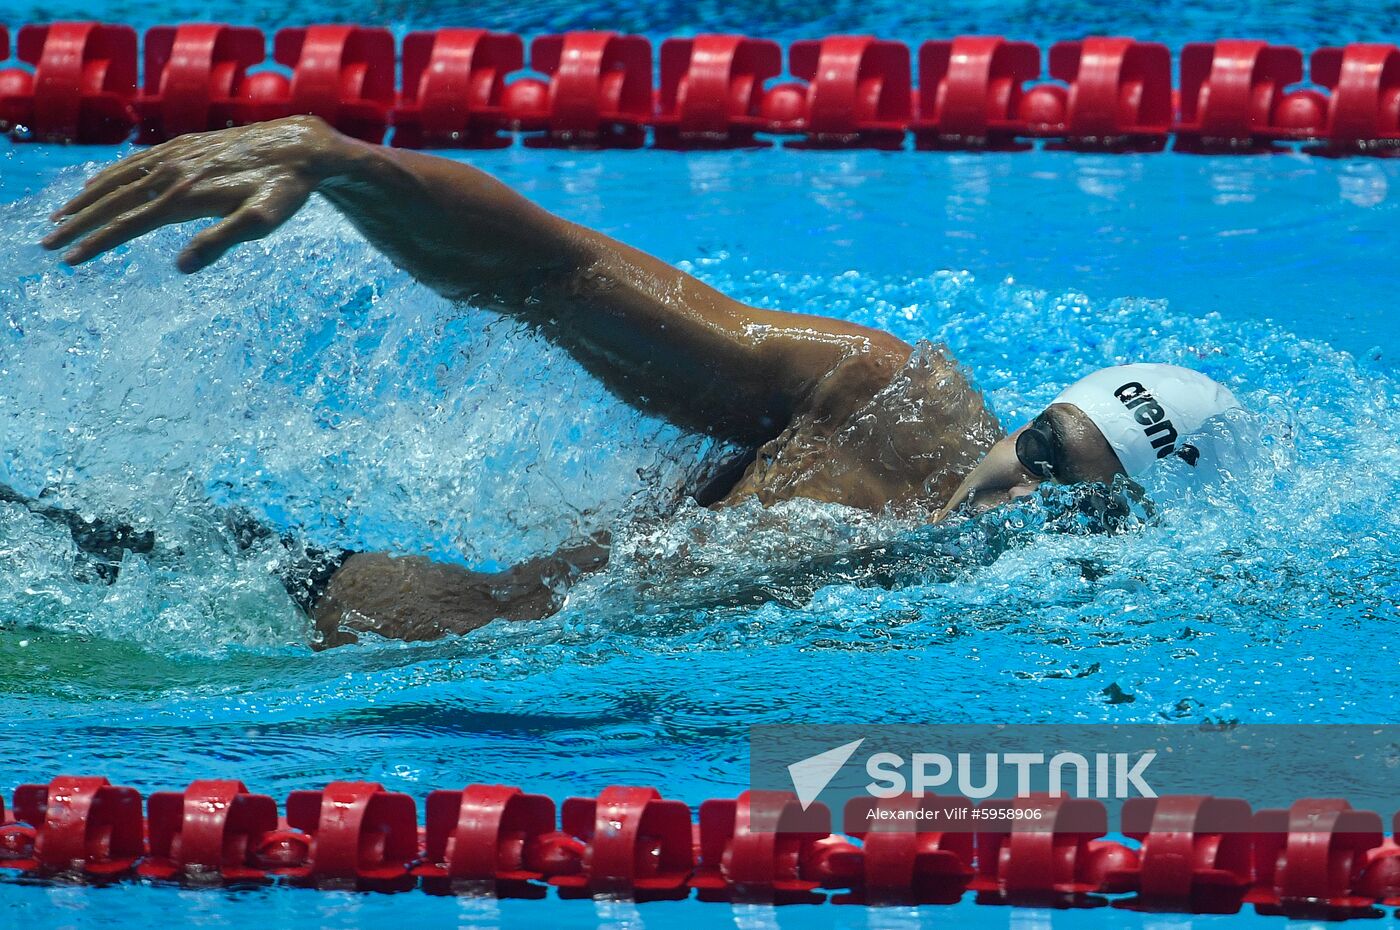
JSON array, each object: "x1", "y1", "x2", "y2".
[{"x1": 134, "y1": 24, "x2": 266, "y2": 143}]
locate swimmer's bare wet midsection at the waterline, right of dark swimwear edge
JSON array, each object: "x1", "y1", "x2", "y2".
[{"x1": 311, "y1": 536, "x2": 608, "y2": 648}]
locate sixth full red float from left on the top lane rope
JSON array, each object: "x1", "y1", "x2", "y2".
[{"x1": 651, "y1": 35, "x2": 783, "y2": 148}]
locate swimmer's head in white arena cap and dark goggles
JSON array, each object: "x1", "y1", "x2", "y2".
[{"x1": 939, "y1": 364, "x2": 1239, "y2": 518}]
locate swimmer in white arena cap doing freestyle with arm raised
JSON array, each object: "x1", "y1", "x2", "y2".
[{"x1": 32, "y1": 116, "x2": 1236, "y2": 644}]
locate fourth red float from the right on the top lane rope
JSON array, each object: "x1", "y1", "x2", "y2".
[{"x1": 913, "y1": 35, "x2": 1040, "y2": 148}]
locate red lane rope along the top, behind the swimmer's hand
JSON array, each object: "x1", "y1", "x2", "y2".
[{"x1": 0, "y1": 22, "x2": 1400, "y2": 154}]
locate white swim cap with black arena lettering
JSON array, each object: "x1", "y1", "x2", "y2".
[{"x1": 1051, "y1": 364, "x2": 1239, "y2": 475}]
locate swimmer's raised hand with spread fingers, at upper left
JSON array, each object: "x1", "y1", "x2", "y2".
[{"x1": 42, "y1": 116, "x2": 343, "y2": 273}]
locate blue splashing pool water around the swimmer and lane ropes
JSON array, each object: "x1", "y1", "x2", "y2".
[{"x1": 0, "y1": 4, "x2": 1400, "y2": 927}]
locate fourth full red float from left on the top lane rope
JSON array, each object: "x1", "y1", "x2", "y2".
[{"x1": 393, "y1": 29, "x2": 525, "y2": 148}]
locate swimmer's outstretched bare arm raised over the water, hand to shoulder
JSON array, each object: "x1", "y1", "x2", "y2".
[{"x1": 45, "y1": 116, "x2": 910, "y2": 443}]
